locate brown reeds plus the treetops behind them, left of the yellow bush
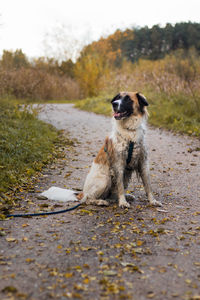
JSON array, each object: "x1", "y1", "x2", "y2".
[{"x1": 0, "y1": 50, "x2": 80, "y2": 101}]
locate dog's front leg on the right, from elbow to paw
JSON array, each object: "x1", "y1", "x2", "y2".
[{"x1": 139, "y1": 163, "x2": 162, "y2": 206}]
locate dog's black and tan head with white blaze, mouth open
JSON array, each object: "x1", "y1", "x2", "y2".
[{"x1": 111, "y1": 92, "x2": 149, "y2": 120}]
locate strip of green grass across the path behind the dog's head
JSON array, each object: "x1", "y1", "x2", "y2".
[{"x1": 75, "y1": 92, "x2": 200, "y2": 136}]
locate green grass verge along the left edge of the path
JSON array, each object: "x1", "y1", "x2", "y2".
[{"x1": 0, "y1": 99, "x2": 58, "y2": 203}]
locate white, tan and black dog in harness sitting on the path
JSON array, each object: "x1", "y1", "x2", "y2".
[{"x1": 42, "y1": 92, "x2": 162, "y2": 208}]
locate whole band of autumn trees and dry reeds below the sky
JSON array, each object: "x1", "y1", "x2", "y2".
[{"x1": 0, "y1": 22, "x2": 200, "y2": 118}]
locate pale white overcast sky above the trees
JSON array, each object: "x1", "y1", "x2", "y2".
[{"x1": 0, "y1": 0, "x2": 200, "y2": 57}]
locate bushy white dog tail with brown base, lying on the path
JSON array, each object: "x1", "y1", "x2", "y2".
[{"x1": 41, "y1": 186, "x2": 83, "y2": 202}]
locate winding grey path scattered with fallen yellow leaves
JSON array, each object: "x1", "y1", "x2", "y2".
[{"x1": 0, "y1": 104, "x2": 200, "y2": 300}]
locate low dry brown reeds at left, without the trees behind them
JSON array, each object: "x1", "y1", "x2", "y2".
[{"x1": 0, "y1": 67, "x2": 80, "y2": 100}]
